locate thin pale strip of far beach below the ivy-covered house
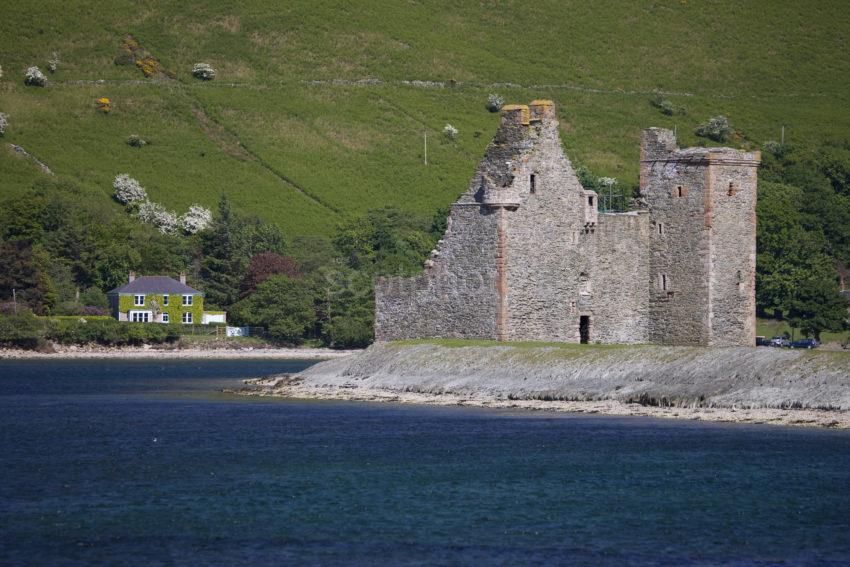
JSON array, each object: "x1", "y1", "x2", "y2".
[{"x1": 0, "y1": 346, "x2": 359, "y2": 360}]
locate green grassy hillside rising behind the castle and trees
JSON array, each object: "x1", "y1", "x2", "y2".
[{"x1": 0, "y1": 0, "x2": 850, "y2": 236}]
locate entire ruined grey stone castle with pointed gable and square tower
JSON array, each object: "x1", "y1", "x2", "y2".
[{"x1": 375, "y1": 100, "x2": 760, "y2": 346}]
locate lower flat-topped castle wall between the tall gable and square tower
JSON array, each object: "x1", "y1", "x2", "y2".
[{"x1": 590, "y1": 212, "x2": 652, "y2": 343}]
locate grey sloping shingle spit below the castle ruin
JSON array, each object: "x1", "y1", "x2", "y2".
[{"x1": 240, "y1": 343, "x2": 850, "y2": 428}]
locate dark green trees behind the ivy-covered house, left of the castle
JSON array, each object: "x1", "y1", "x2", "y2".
[{"x1": 0, "y1": 180, "x2": 446, "y2": 347}]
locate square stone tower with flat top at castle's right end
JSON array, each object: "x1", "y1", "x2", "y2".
[{"x1": 640, "y1": 128, "x2": 760, "y2": 346}]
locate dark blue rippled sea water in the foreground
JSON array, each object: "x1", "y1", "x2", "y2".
[{"x1": 0, "y1": 360, "x2": 850, "y2": 566}]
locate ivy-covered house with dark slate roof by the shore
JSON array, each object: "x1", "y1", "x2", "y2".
[{"x1": 106, "y1": 272, "x2": 226, "y2": 325}]
